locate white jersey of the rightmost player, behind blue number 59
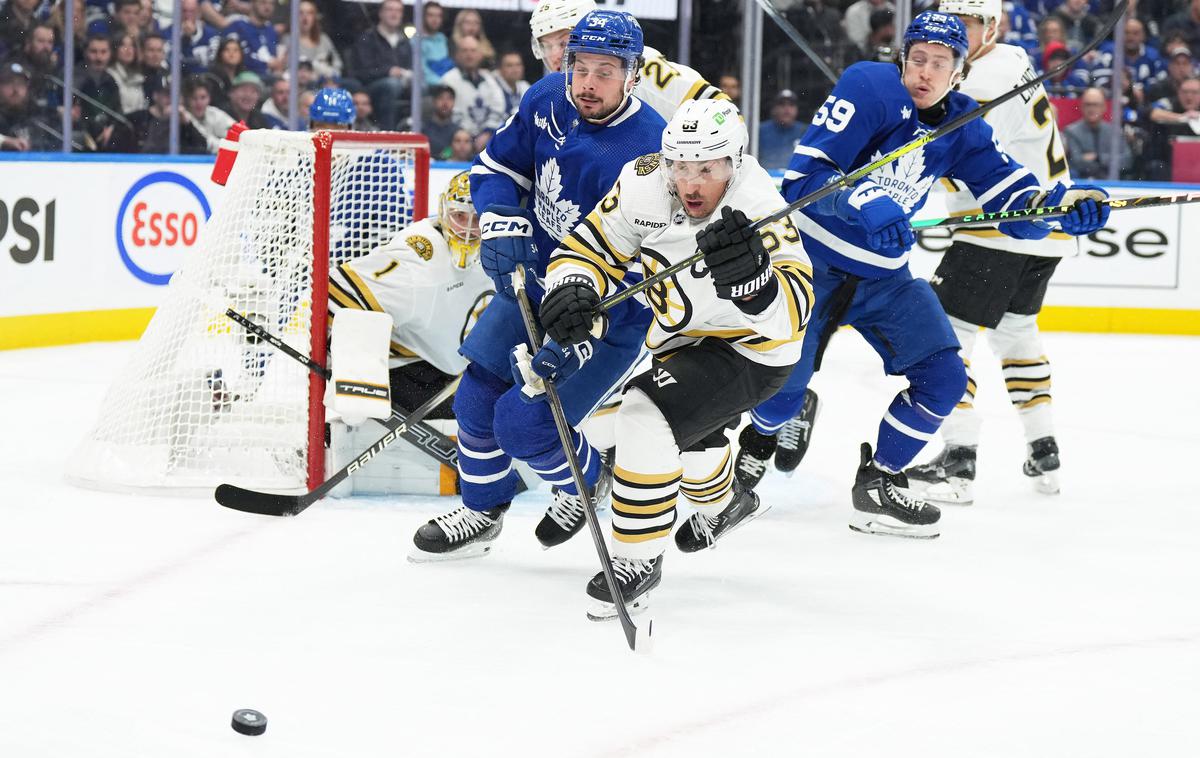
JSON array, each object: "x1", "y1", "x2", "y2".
[{"x1": 942, "y1": 44, "x2": 1078, "y2": 258}]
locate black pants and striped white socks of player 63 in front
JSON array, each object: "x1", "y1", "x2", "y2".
[{"x1": 612, "y1": 338, "x2": 788, "y2": 559}]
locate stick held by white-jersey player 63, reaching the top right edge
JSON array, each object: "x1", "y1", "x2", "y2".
[{"x1": 596, "y1": 0, "x2": 1129, "y2": 313}]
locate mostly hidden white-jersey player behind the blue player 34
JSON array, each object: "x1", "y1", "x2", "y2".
[{"x1": 529, "y1": 0, "x2": 728, "y2": 121}]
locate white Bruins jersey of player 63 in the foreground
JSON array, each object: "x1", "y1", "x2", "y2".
[{"x1": 546, "y1": 154, "x2": 812, "y2": 366}]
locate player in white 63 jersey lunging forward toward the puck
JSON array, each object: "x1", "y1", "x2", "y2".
[{"x1": 518, "y1": 100, "x2": 812, "y2": 619}]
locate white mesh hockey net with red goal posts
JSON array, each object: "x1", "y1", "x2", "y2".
[{"x1": 67, "y1": 130, "x2": 430, "y2": 492}]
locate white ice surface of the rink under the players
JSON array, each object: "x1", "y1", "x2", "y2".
[{"x1": 0, "y1": 332, "x2": 1200, "y2": 758}]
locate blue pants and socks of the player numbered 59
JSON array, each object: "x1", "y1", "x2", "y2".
[{"x1": 750, "y1": 261, "x2": 966, "y2": 471}]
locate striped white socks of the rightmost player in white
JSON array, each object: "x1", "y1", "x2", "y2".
[{"x1": 942, "y1": 313, "x2": 1054, "y2": 446}]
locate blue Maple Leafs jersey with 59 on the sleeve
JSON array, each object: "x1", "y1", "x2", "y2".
[{"x1": 784, "y1": 62, "x2": 1037, "y2": 278}]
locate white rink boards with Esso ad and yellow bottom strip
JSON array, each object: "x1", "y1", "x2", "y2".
[{"x1": 0, "y1": 154, "x2": 1200, "y2": 349}]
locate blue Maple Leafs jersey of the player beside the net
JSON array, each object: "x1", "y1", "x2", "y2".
[{"x1": 470, "y1": 73, "x2": 666, "y2": 276}]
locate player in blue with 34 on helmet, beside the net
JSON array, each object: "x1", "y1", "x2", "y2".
[{"x1": 410, "y1": 11, "x2": 666, "y2": 560}]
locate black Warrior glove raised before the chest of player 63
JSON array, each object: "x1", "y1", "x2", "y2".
[{"x1": 696, "y1": 206, "x2": 778, "y2": 313}]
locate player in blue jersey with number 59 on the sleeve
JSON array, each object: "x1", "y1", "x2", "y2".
[{"x1": 724, "y1": 12, "x2": 1108, "y2": 537}]
